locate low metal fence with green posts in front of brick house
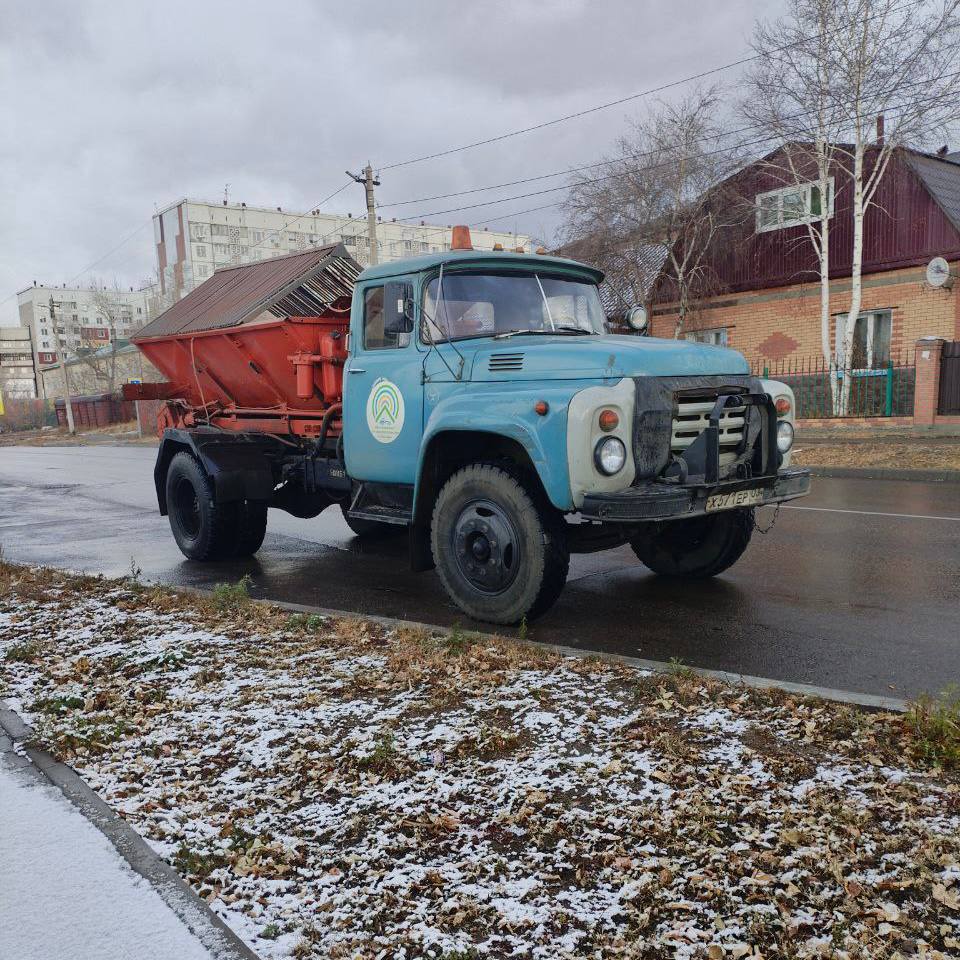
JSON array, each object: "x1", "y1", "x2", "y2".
[{"x1": 754, "y1": 355, "x2": 916, "y2": 419}]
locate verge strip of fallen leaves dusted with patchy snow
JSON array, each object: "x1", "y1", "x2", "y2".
[{"x1": 0, "y1": 575, "x2": 960, "y2": 960}]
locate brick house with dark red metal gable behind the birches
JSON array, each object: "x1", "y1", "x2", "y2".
[{"x1": 651, "y1": 144, "x2": 960, "y2": 366}]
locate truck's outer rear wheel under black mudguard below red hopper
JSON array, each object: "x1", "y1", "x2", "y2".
[{"x1": 167, "y1": 451, "x2": 239, "y2": 561}]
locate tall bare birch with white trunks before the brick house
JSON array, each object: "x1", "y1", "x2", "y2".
[{"x1": 748, "y1": 0, "x2": 960, "y2": 413}]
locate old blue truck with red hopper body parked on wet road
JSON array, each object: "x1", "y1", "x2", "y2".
[{"x1": 129, "y1": 228, "x2": 810, "y2": 624}]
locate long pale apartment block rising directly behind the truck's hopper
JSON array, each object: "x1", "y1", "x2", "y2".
[{"x1": 153, "y1": 200, "x2": 530, "y2": 300}]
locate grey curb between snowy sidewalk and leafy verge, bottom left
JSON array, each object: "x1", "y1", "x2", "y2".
[{"x1": 0, "y1": 700, "x2": 260, "y2": 960}]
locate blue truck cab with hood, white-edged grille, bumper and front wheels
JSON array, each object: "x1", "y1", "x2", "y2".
[{"x1": 334, "y1": 232, "x2": 809, "y2": 623}]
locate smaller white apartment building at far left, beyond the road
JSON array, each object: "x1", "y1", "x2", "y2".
[{"x1": 17, "y1": 284, "x2": 155, "y2": 378}]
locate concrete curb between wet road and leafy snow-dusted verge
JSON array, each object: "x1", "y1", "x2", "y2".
[{"x1": 175, "y1": 587, "x2": 910, "y2": 713}]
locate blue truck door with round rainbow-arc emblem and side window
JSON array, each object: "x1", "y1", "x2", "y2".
[{"x1": 343, "y1": 278, "x2": 423, "y2": 484}]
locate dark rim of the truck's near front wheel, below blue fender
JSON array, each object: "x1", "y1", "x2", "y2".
[{"x1": 452, "y1": 500, "x2": 521, "y2": 594}]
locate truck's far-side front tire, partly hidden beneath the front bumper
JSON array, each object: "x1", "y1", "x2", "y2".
[{"x1": 630, "y1": 508, "x2": 753, "y2": 578}]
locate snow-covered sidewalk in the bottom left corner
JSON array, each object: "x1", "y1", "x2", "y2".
[{"x1": 0, "y1": 735, "x2": 218, "y2": 960}]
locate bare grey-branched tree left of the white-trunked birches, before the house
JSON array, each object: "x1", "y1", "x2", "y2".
[{"x1": 565, "y1": 87, "x2": 737, "y2": 337}]
